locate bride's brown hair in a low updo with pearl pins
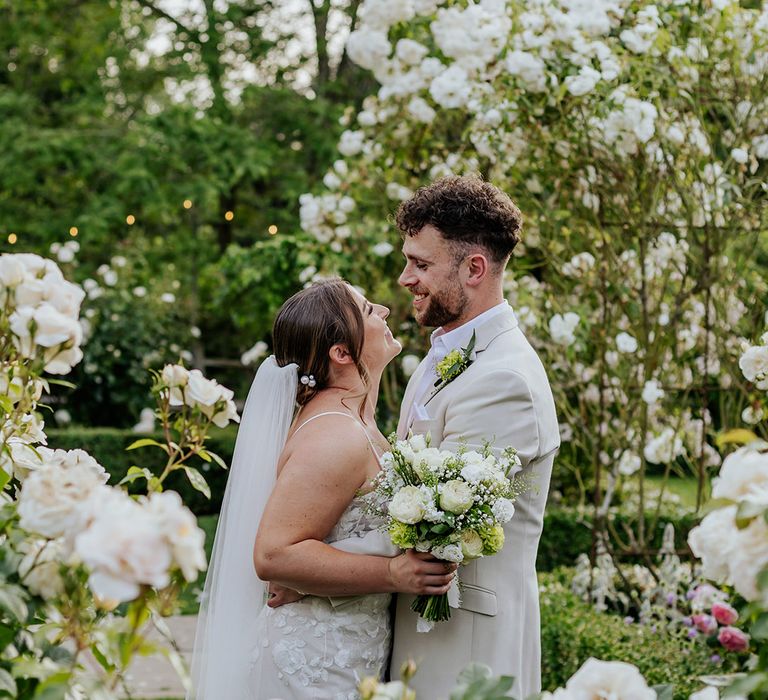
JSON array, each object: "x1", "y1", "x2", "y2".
[{"x1": 272, "y1": 278, "x2": 368, "y2": 406}]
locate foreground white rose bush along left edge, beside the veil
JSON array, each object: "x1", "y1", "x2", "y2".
[{"x1": 0, "y1": 254, "x2": 239, "y2": 698}]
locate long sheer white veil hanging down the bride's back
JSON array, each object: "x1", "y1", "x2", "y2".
[{"x1": 187, "y1": 355, "x2": 298, "y2": 700}]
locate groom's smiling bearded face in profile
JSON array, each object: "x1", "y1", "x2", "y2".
[{"x1": 398, "y1": 225, "x2": 469, "y2": 330}]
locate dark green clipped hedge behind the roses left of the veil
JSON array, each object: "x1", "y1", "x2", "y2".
[{"x1": 47, "y1": 428, "x2": 236, "y2": 515}]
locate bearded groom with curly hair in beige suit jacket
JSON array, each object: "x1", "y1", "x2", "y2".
[{"x1": 391, "y1": 177, "x2": 560, "y2": 700}]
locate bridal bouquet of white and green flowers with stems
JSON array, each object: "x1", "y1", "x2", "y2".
[{"x1": 369, "y1": 435, "x2": 522, "y2": 622}]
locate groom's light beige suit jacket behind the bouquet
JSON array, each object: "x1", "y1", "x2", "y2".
[{"x1": 391, "y1": 308, "x2": 560, "y2": 700}]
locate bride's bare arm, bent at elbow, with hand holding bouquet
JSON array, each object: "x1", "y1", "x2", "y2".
[{"x1": 253, "y1": 418, "x2": 455, "y2": 596}]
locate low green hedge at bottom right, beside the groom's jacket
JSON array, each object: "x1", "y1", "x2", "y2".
[{"x1": 539, "y1": 569, "x2": 722, "y2": 699}]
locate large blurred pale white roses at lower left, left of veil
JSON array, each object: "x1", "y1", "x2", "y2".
[{"x1": 18, "y1": 447, "x2": 206, "y2": 607}]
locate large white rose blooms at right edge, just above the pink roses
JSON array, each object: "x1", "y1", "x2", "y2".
[{"x1": 688, "y1": 444, "x2": 768, "y2": 605}]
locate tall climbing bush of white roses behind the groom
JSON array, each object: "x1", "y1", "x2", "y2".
[{"x1": 301, "y1": 0, "x2": 768, "y2": 584}]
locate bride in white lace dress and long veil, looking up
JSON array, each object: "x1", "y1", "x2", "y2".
[{"x1": 188, "y1": 279, "x2": 455, "y2": 700}]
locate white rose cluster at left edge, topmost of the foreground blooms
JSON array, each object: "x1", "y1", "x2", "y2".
[{"x1": 0, "y1": 253, "x2": 85, "y2": 374}]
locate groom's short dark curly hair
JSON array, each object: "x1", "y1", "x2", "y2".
[{"x1": 395, "y1": 176, "x2": 523, "y2": 266}]
